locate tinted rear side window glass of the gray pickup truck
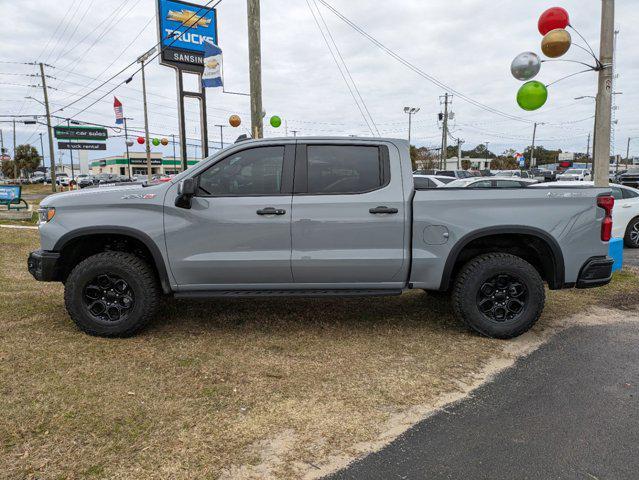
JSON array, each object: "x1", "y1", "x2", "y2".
[{"x1": 307, "y1": 145, "x2": 385, "y2": 194}]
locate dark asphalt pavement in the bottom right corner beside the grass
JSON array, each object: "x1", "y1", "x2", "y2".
[{"x1": 329, "y1": 324, "x2": 639, "y2": 480}]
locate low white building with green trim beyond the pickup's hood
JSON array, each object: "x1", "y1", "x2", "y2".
[{"x1": 89, "y1": 152, "x2": 199, "y2": 175}]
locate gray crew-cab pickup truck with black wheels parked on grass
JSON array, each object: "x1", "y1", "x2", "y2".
[{"x1": 28, "y1": 138, "x2": 614, "y2": 338}]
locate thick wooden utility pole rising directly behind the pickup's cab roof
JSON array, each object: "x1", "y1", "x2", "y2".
[{"x1": 246, "y1": 0, "x2": 264, "y2": 138}]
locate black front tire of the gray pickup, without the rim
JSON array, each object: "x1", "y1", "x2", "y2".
[{"x1": 64, "y1": 252, "x2": 162, "y2": 337}]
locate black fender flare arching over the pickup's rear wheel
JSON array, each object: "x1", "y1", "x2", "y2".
[{"x1": 439, "y1": 225, "x2": 566, "y2": 290}]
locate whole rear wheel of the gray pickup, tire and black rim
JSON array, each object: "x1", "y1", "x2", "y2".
[{"x1": 452, "y1": 253, "x2": 546, "y2": 339}]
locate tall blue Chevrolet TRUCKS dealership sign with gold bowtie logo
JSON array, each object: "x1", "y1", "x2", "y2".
[{"x1": 157, "y1": 0, "x2": 217, "y2": 73}]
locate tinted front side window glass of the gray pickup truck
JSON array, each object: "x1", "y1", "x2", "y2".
[{"x1": 199, "y1": 147, "x2": 284, "y2": 196}]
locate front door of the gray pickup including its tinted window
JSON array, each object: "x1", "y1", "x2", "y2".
[{"x1": 165, "y1": 146, "x2": 294, "y2": 290}]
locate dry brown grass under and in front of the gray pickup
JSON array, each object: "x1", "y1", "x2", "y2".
[{"x1": 0, "y1": 229, "x2": 636, "y2": 479}]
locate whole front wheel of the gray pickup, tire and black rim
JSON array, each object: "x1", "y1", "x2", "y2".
[{"x1": 64, "y1": 252, "x2": 161, "y2": 337}]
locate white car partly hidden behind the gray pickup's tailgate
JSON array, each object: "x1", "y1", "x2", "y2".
[{"x1": 534, "y1": 181, "x2": 639, "y2": 248}]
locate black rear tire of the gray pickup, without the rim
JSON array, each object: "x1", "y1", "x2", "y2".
[{"x1": 452, "y1": 253, "x2": 546, "y2": 339}]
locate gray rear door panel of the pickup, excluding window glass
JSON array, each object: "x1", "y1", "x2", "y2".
[{"x1": 291, "y1": 142, "x2": 407, "y2": 288}]
